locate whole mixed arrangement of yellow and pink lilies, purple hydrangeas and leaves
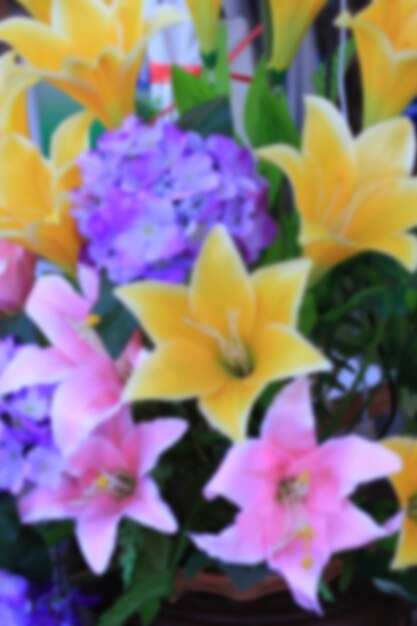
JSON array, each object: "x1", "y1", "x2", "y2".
[{"x1": 0, "y1": 0, "x2": 417, "y2": 626}]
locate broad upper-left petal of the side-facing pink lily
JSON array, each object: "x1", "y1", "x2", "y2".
[{"x1": 26, "y1": 276, "x2": 93, "y2": 363}]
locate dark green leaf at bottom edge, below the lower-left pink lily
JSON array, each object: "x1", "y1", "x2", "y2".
[{"x1": 98, "y1": 571, "x2": 172, "y2": 626}]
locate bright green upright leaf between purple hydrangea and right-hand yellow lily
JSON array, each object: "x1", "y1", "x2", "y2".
[{"x1": 244, "y1": 60, "x2": 300, "y2": 148}]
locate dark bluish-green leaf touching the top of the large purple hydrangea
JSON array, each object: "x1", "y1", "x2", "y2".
[{"x1": 177, "y1": 96, "x2": 233, "y2": 137}]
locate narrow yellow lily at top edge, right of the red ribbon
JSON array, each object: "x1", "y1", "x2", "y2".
[{"x1": 269, "y1": 0, "x2": 327, "y2": 72}]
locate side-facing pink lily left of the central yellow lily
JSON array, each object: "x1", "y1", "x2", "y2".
[{"x1": 0, "y1": 266, "x2": 140, "y2": 455}]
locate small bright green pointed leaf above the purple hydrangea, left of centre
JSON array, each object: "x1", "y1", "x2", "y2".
[{"x1": 172, "y1": 65, "x2": 216, "y2": 115}]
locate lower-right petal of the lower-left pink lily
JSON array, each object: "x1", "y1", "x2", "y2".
[{"x1": 123, "y1": 478, "x2": 178, "y2": 533}]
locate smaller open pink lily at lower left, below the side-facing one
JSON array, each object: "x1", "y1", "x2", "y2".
[{"x1": 19, "y1": 410, "x2": 187, "y2": 574}]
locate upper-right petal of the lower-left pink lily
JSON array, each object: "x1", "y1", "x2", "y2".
[{"x1": 130, "y1": 418, "x2": 188, "y2": 476}]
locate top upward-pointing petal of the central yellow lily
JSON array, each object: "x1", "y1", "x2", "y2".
[{"x1": 190, "y1": 226, "x2": 255, "y2": 339}]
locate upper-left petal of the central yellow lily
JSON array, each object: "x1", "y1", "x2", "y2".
[{"x1": 116, "y1": 281, "x2": 212, "y2": 345}]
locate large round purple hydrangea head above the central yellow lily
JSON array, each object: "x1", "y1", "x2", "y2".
[{"x1": 72, "y1": 117, "x2": 276, "y2": 284}]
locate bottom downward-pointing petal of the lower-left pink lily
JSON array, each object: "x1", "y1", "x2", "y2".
[{"x1": 76, "y1": 515, "x2": 119, "y2": 575}]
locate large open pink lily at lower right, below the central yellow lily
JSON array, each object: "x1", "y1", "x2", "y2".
[{"x1": 192, "y1": 379, "x2": 401, "y2": 613}]
